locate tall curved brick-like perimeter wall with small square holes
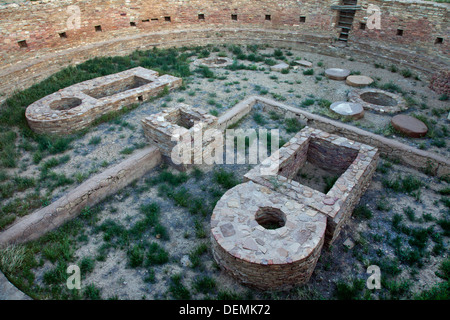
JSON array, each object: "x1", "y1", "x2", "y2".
[{"x1": 0, "y1": 0, "x2": 450, "y2": 100}]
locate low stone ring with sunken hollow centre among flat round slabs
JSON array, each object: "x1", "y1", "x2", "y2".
[{"x1": 348, "y1": 88, "x2": 408, "y2": 113}]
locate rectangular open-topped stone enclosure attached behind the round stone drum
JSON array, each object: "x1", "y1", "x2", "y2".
[{"x1": 244, "y1": 127, "x2": 379, "y2": 245}]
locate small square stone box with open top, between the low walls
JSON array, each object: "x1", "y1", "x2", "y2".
[{"x1": 142, "y1": 103, "x2": 217, "y2": 170}]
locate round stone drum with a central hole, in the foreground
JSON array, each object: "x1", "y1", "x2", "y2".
[{"x1": 211, "y1": 181, "x2": 326, "y2": 290}]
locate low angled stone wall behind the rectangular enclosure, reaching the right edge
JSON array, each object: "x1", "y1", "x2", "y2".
[{"x1": 218, "y1": 96, "x2": 450, "y2": 177}]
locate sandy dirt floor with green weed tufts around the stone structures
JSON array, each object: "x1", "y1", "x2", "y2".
[{"x1": 2, "y1": 46, "x2": 450, "y2": 299}]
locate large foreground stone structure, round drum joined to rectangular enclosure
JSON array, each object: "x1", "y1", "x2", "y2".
[{"x1": 211, "y1": 127, "x2": 379, "y2": 290}]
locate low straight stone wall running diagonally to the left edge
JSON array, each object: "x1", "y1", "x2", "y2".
[{"x1": 0, "y1": 147, "x2": 161, "y2": 246}]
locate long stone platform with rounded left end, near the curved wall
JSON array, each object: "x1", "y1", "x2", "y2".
[{"x1": 25, "y1": 67, "x2": 182, "y2": 134}]
